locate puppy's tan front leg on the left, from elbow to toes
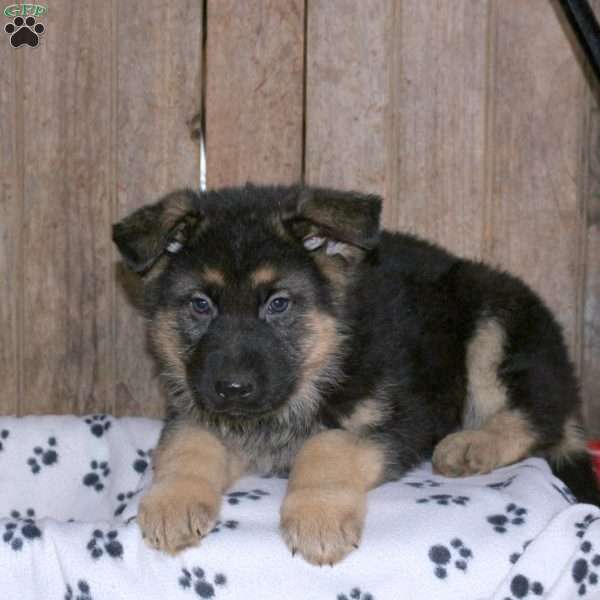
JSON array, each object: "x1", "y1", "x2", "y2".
[{"x1": 138, "y1": 425, "x2": 243, "y2": 554}]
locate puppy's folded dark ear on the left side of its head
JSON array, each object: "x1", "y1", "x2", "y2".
[{"x1": 113, "y1": 190, "x2": 202, "y2": 274}]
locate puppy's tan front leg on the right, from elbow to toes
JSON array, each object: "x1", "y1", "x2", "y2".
[{"x1": 281, "y1": 429, "x2": 384, "y2": 565}]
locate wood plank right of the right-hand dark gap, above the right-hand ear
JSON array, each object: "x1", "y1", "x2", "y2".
[{"x1": 305, "y1": 0, "x2": 390, "y2": 194}]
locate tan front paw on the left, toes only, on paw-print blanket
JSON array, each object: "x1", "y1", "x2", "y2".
[{"x1": 138, "y1": 479, "x2": 221, "y2": 554}]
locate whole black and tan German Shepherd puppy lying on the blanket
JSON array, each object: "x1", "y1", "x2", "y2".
[{"x1": 113, "y1": 185, "x2": 600, "y2": 565}]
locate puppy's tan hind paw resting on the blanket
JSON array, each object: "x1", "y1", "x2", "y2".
[{"x1": 433, "y1": 431, "x2": 500, "y2": 477}]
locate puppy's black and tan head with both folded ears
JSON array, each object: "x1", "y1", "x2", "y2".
[{"x1": 113, "y1": 186, "x2": 381, "y2": 419}]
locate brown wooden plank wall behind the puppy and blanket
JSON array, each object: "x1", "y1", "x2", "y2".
[{"x1": 0, "y1": 0, "x2": 600, "y2": 435}]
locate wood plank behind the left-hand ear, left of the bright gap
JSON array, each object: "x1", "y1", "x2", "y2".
[{"x1": 112, "y1": 0, "x2": 202, "y2": 416}]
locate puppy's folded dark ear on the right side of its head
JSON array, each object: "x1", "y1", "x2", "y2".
[{"x1": 284, "y1": 188, "x2": 382, "y2": 262}]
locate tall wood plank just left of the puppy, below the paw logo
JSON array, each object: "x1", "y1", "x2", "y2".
[{"x1": 19, "y1": 0, "x2": 112, "y2": 413}]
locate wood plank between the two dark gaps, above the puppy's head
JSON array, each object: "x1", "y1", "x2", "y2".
[{"x1": 206, "y1": 0, "x2": 304, "y2": 187}]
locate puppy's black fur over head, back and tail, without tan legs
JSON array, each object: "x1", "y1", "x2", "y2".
[{"x1": 114, "y1": 186, "x2": 600, "y2": 504}]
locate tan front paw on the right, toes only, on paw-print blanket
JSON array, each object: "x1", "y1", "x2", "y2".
[{"x1": 280, "y1": 488, "x2": 366, "y2": 566}]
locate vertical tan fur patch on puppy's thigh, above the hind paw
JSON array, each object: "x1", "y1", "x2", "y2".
[{"x1": 463, "y1": 319, "x2": 507, "y2": 429}]
